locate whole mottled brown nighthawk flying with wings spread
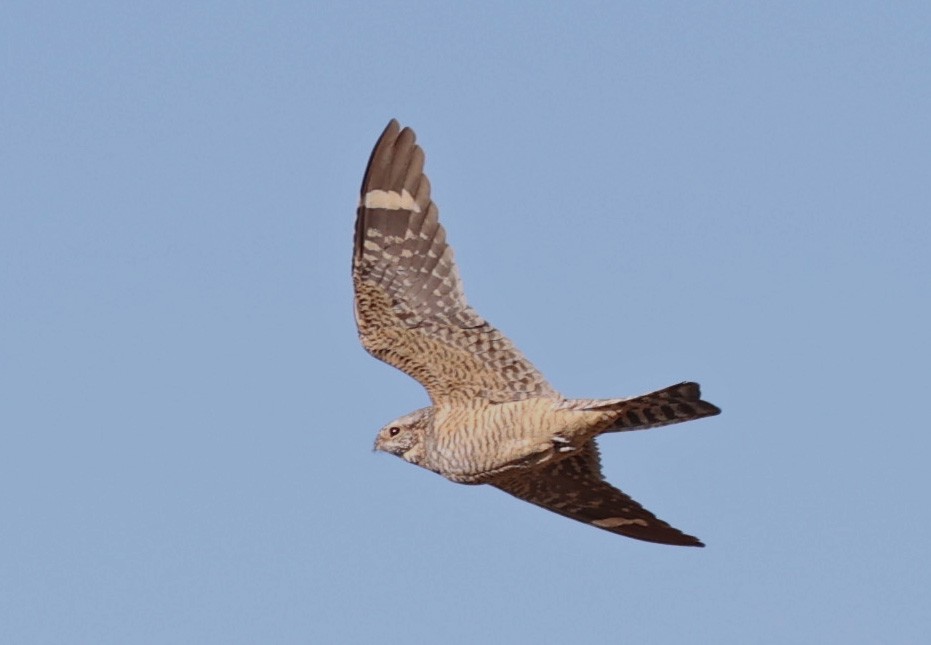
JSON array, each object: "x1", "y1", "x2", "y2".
[{"x1": 352, "y1": 119, "x2": 720, "y2": 546}]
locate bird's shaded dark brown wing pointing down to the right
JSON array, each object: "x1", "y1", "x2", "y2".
[{"x1": 494, "y1": 441, "x2": 705, "y2": 546}]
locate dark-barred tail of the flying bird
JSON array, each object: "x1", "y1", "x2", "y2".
[{"x1": 567, "y1": 382, "x2": 721, "y2": 432}]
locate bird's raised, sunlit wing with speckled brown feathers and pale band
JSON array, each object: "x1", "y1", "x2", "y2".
[{"x1": 352, "y1": 119, "x2": 557, "y2": 403}]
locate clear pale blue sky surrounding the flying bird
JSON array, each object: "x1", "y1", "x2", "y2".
[{"x1": 0, "y1": 1, "x2": 931, "y2": 645}]
